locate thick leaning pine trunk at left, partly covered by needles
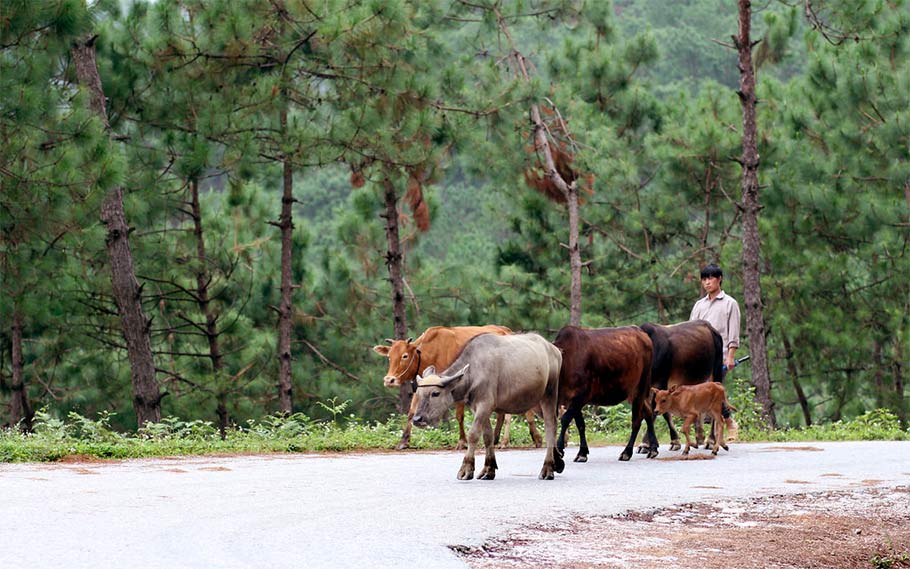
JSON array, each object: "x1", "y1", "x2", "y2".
[{"x1": 71, "y1": 36, "x2": 162, "y2": 427}]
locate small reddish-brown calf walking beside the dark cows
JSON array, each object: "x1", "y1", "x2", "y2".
[{"x1": 653, "y1": 381, "x2": 735, "y2": 454}]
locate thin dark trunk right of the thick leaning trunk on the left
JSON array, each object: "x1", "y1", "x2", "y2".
[{"x1": 190, "y1": 179, "x2": 228, "y2": 440}]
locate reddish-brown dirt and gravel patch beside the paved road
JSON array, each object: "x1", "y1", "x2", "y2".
[{"x1": 460, "y1": 486, "x2": 910, "y2": 569}]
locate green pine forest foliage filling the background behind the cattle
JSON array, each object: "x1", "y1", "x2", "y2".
[{"x1": 0, "y1": 0, "x2": 910, "y2": 429}]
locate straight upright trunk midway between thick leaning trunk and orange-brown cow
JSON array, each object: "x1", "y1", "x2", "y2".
[{"x1": 278, "y1": 104, "x2": 294, "y2": 414}]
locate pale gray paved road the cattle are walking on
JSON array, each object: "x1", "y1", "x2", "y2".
[{"x1": 0, "y1": 442, "x2": 910, "y2": 569}]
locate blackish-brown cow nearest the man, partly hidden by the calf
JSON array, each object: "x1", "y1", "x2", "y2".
[{"x1": 639, "y1": 320, "x2": 729, "y2": 452}]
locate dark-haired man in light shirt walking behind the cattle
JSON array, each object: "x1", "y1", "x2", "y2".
[{"x1": 689, "y1": 263, "x2": 740, "y2": 440}]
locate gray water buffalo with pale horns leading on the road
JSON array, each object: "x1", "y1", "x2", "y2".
[{"x1": 413, "y1": 334, "x2": 565, "y2": 480}]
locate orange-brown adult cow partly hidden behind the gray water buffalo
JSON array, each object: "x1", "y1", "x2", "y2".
[{"x1": 373, "y1": 324, "x2": 540, "y2": 450}]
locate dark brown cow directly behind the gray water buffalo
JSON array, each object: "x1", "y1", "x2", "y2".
[{"x1": 553, "y1": 326, "x2": 657, "y2": 462}]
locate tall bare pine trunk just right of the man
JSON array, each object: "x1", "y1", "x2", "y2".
[{"x1": 733, "y1": 0, "x2": 777, "y2": 429}]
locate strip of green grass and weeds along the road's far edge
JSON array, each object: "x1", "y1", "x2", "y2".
[{"x1": 0, "y1": 402, "x2": 910, "y2": 462}]
